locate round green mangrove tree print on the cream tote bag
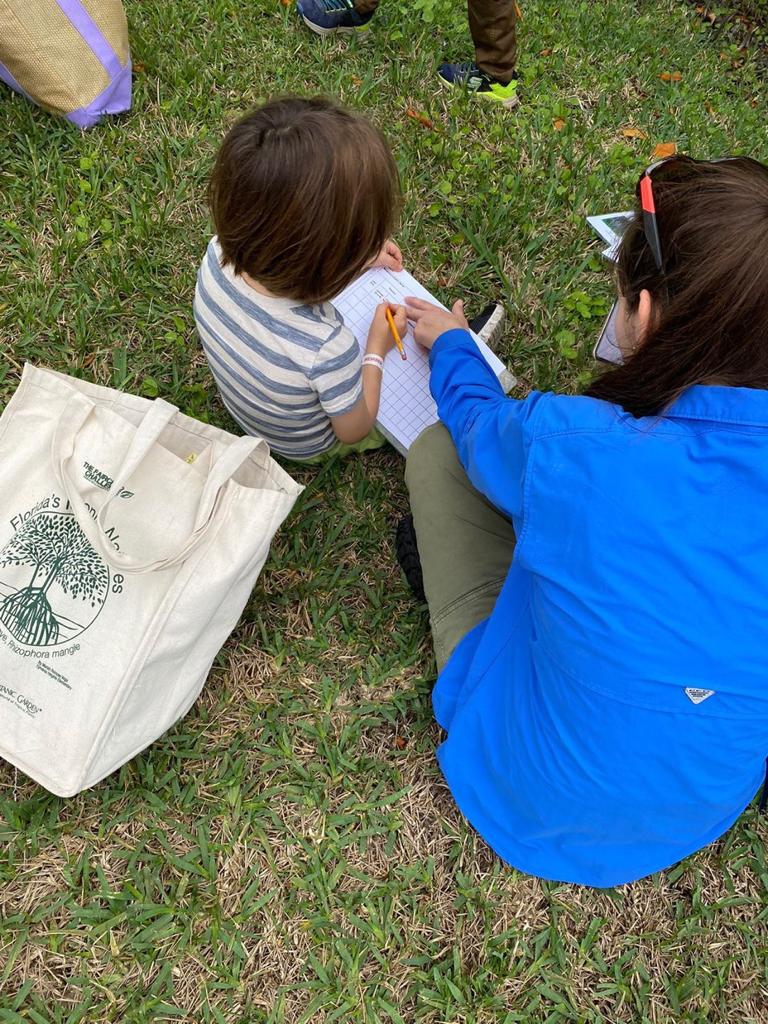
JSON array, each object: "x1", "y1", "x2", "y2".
[{"x1": 0, "y1": 499, "x2": 112, "y2": 647}]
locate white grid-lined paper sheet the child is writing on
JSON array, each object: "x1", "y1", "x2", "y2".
[{"x1": 333, "y1": 267, "x2": 514, "y2": 455}]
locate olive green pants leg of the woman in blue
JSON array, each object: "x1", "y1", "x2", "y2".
[{"x1": 406, "y1": 423, "x2": 515, "y2": 672}]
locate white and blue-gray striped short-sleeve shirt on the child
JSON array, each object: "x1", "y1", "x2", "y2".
[{"x1": 194, "y1": 238, "x2": 362, "y2": 459}]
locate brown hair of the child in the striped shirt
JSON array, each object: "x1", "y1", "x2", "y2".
[{"x1": 209, "y1": 97, "x2": 399, "y2": 303}]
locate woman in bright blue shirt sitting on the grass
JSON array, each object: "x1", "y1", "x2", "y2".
[{"x1": 399, "y1": 158, "x2": 768, "y2": 886}]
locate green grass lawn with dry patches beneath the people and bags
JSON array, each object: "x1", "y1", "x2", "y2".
[{"x1": 0, "y1": 0, "x2": 768, "y2": 1024}]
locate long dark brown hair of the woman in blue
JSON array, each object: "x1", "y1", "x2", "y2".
[{"x1": 586, "y1": 157, "x2": 768, "y2": 417}]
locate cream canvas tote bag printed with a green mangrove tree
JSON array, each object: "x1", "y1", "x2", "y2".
[{"x1": 0, "y1": 366, "x2": 302, "y2": 797}]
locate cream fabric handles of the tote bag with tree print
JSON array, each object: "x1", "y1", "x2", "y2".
[{"x1": 51, "y1": 393, "x2": 266, "y2": 573}]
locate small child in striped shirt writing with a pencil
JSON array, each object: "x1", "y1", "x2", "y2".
[{"x1": 194, "y1": 97, "x2": 407, "y2": 461}]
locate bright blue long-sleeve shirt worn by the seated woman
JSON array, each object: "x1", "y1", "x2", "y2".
[{"x1": 430, "y1": 330, "x2": 768, "y2": 886}]
